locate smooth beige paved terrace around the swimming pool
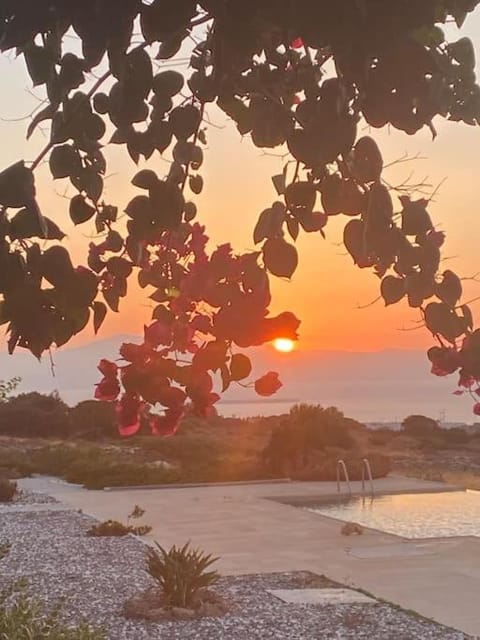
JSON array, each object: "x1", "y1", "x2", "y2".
[{"x1": 20, "y1": 476, "x2": 480, "y2": 636}]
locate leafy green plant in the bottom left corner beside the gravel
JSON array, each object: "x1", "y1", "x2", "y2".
[{"x1": 0, "y1": 581, "x2": 106, "y2": 640}]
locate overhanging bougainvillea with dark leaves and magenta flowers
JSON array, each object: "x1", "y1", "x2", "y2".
[{"x1": 0, "y1": 0, "x2": 480, "y2": 435}]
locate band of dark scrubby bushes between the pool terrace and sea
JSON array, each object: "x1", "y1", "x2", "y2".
[{"x1": 0, "y1": 393, "x2": 480, "y2": 488}]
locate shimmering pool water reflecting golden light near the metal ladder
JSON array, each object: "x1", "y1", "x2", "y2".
[{"x1": 304, "y1": 491, "x2": 480, "y2": 538}]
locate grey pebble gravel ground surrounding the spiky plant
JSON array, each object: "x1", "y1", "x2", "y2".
[{"x1": 0, "y1": 494, "x2": 469, "y2": 640}]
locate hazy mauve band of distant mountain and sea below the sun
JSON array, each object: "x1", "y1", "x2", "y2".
[{"x1": 0, "y1": 335, "x2": 466, "y2": 423}]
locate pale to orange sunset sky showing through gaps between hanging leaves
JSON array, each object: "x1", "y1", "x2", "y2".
[{"x1": 0, "y1": 12, "x2": 480, "y2": 351}]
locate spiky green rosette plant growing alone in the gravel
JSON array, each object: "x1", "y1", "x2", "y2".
[{"x1": 147, "y1": 542, "x2": 220, "y2": 608}]
